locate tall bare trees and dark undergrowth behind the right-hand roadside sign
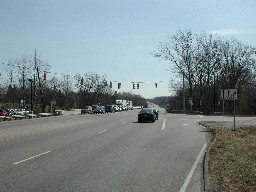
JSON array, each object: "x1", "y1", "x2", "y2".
[{"x1": 153, "y1": 30, "x2": 256, "y2": 114}]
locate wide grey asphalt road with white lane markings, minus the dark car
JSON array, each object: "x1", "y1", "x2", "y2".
[{"x1": 0, "y1": 109, "x2": 206, "y2": 192}]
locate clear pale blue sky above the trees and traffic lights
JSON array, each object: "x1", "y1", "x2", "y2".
[{"x1": 0, "y1": 0, "x2": 256, "y2": 98}]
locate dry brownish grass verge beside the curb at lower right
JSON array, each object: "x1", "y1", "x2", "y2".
[{"x1": 201, "y1": 122, "x2": 256, "y2": 192}]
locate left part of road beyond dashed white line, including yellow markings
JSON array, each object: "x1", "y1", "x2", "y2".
[{"x1": 0, "y1": 114, "x2": 136, "y2": 166}]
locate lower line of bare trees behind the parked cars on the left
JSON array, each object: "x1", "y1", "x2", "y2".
[{"x1": 0, "y1": 50, "x2": 146, "y2": 113}]
